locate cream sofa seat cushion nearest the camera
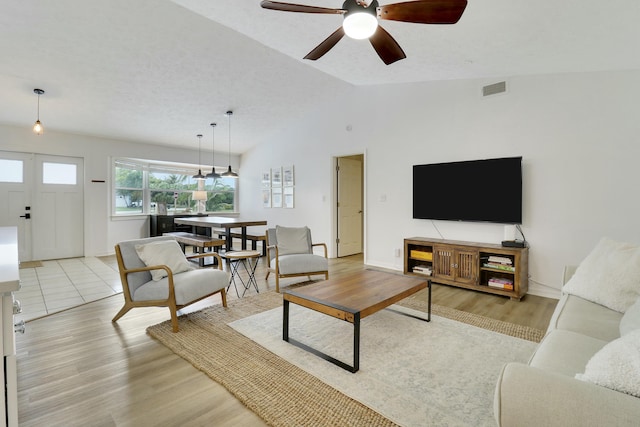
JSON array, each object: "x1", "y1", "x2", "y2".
[{"x1": 529, "y1": 330, "x2": 608, "y2": 377}]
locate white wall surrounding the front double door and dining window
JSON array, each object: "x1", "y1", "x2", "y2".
[{"x1": 0, "y1": 124, "x2": 239, "y2": 256}]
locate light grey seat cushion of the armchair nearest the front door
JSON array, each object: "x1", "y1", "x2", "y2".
[{"x1": 132, "y1": 268, "x2": 229, "y2": 305}]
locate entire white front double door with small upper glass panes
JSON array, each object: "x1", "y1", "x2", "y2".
[{"x1": 0, "y1": 151, "x2": 84, "y2": 261}]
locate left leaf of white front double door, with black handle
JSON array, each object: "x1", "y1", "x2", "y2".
[{"x1": 0, "y1": 151, "x2": 33, "y2": 261}]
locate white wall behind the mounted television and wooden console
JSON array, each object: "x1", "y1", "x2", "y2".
[{"x1": 240, "y1": 71, "x2": 640, "y2": 297}]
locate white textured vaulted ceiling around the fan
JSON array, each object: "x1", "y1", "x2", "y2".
[{"x1": 0, "y1": 0, "x2": 640, "y2": 153}]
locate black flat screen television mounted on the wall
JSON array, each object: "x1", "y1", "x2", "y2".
[{"x1": 413, "y1": 157, "x2": 522, "y2": 224}]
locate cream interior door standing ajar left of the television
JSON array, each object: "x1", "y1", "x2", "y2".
[{"x1": 337, "y1": 155, "x2": 363, "y2": 257}]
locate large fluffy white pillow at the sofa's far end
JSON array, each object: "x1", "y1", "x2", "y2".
[{"x1": 562, "y1": 238, "x2": 640, "y2": 313}]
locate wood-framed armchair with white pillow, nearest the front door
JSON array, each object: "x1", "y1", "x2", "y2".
[{"x1": 112, "y1": 236, "x2": 229, "y2": 332}]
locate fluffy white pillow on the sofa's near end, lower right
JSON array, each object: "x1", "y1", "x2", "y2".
[{"x1": 576, "y1": 329, "x2": 640, "y2": 397}]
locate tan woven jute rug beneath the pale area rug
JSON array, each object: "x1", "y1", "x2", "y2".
[{"x1": 147, "y1": 292, "x2": 543, "y2": 426}]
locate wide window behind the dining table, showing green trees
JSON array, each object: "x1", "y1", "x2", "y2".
[{"x1": 113, "y1": 159, "x2": 237, "y2": 215}]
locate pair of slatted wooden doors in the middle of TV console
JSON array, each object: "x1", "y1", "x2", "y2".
[{"x1": 433, "y1": 246, "x2": 478, "y2": 284}]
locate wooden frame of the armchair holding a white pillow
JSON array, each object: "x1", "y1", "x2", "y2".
[{"x1": 111, "y1": 245, "x2": 227, "y2": 332}]
